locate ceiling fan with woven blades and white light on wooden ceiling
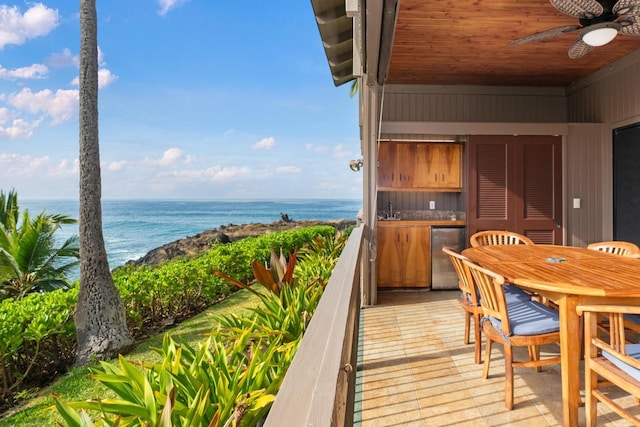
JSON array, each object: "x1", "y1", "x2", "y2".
[{"x1": 510, "y1": 0, "x2": 640, "y2": 59}]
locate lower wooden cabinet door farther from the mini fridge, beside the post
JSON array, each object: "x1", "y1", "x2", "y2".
[{"x1": 376, "y1": 226, "x2": 404, "y2": 287}]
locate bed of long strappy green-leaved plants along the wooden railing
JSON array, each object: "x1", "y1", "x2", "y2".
[{"x1": 54, "y1": 229, "x2": 345, "y2": 427}]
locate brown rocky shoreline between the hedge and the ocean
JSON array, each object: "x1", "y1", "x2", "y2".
[{"x1": 127, "y1": 219, "x2": 356, "y2": 266}]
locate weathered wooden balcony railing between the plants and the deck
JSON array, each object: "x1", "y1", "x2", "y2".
[{"x1": 265, "y1": 225, "x2": 365, "y2": 427}]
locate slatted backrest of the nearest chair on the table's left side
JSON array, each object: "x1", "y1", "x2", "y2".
[{"x1": 463, "y1": 259, "x2": 511, "y2": 335}]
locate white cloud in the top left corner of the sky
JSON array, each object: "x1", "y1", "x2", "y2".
[{"x1": 0, "y1": 3, "x2": 59, "y2": 49}]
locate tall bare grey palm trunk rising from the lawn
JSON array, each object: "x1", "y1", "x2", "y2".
[{"x1": 75, "y1": 0, "x2": 133, "y2": 365}]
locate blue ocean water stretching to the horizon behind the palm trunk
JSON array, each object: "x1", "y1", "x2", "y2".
[{"x1": 18, "y1": 199, "x2": 362, "y2": 269}]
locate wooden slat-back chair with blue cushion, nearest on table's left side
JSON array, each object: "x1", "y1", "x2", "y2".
[{"x1": 464, "y1": 259, "x2": 560, "y2": 410}]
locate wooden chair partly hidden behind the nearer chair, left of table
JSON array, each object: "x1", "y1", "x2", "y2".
[{"x1": 442, "y1": 247, "x2": 483, "y2": 364}]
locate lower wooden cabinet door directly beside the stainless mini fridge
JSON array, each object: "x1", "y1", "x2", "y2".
[{"x1": 403, "y1": 226, "x2": 431, "y2": 287}]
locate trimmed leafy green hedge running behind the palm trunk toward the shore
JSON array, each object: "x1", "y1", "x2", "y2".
[{"x1": 0, "y1": 226, "x2": 336, "y2": 409}]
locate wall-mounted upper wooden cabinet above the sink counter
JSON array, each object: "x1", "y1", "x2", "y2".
[{"x1": 378, "y1": 142, "x2": 462, "y2": 191}]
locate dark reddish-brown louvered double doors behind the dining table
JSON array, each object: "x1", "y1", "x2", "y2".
[{"x1": 467, "y1": 136, "x2": 562, "y2": 244}]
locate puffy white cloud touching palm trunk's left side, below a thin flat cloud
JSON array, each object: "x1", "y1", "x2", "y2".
[{"x1": 9, "y1": 88, "x2": 78, "y2": 125}]
